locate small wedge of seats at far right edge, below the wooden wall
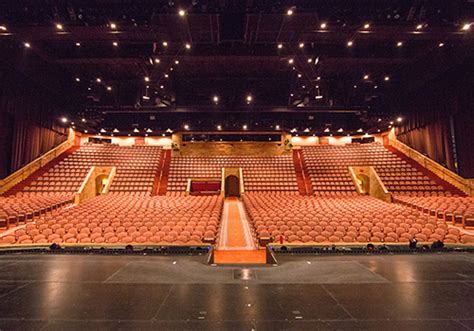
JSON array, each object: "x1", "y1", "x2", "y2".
[{"x1": 395, "y1": 196, "x2": 474, "y2": 226}]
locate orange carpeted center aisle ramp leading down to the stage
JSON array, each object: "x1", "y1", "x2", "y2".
[{"x1": 214, "y1": 197, "x2": 265, "y2": 264}]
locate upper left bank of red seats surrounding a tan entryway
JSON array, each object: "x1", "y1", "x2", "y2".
[{"x1": 24, "y1": 144, "x2": 161, "y2": 193}]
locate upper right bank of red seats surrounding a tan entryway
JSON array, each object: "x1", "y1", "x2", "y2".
[{"x1": 303, "y1": 143, "x2": 451, "y2": 196}]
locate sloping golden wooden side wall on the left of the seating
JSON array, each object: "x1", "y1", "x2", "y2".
[{"x1": 0, "y1": 136, "x2": 74, "y2": 194}]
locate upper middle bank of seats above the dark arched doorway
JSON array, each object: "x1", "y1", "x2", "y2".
[{"x1": 168, "y1": 155, "x2": 298, "y2": 192}]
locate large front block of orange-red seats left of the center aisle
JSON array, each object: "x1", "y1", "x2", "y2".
[{"x1": 0, "y1": 193, "x2": 223, "y2": 245}]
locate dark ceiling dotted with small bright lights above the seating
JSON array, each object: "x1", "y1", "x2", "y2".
[{"x1": 0, "y1": 0, "x2": 474, "y2": 132}]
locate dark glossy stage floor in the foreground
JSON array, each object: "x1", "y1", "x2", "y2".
[{"x1": 0, "y1": 253, "x2": 474, "y2": 331}]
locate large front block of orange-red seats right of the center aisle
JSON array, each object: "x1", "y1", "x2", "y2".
[{"x1": 244, "y1": 193, "x2": 474, "y2": 243}]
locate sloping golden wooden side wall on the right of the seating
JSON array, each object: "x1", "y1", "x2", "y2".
[{"x1": 389, "y1": 139, "x2": 474, "y2": 196}]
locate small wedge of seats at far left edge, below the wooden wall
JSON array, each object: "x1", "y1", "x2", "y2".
[{"x1": 0, "y1": 193, "x2": 73, "y2": 227}]
